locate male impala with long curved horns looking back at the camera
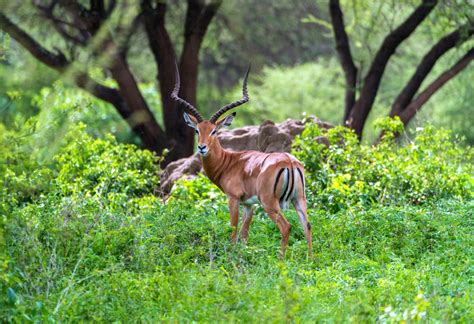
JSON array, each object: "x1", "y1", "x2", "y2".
[{"x1": 171, "y1": 67, "x2": 313, "y2": 257}]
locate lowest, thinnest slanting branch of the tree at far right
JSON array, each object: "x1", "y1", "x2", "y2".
[{"x1": 400, "y1": 48, "x2": 474, "y2": 125}]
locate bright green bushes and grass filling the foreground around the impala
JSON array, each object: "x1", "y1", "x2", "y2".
[{"x1": 0, "y1": 120, "x2": 474, "y2": 322}]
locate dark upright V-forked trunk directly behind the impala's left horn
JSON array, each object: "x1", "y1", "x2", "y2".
[{"x1": 142, "y1": 0, "x2": 221, "y2": 164}]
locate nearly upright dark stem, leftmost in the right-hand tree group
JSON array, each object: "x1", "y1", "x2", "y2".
[{"x1": 329, "y1": 0, "x2": 357, "y2": 122}]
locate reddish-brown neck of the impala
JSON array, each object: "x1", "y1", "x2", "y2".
[{"x1": 201, "y1": 140, "x2": 231, "y2": 187}]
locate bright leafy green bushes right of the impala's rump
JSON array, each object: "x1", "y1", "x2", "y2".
[{"x1": 294, "y1": 118, "x2": 473, "y2": 212}]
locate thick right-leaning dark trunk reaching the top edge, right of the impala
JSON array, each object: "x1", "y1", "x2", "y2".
[{"x1": 347, "y1": 0, "x2": 438, "y2": 138}]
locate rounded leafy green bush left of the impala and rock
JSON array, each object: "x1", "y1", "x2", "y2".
[{"x1": 55, "y1": 129, "x2": 158, "y2": 197}]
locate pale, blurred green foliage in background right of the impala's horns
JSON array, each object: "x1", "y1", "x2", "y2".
[{"x1": 227, "y1": 59, "x2": 344, "y2": 125}]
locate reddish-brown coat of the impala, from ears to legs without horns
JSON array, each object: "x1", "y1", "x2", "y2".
[{"x1": 190, "y1": 116, "x2": 312, "y2": 257}]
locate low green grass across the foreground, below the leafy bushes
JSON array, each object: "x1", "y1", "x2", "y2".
[{"x1": 2, "y1": 197, "x2": 474, "y2": 322}]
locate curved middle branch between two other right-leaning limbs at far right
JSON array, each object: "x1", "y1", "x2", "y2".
[{"x1": 390, "y1": 23, "x2": 474, "y2": 117}]
